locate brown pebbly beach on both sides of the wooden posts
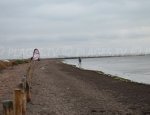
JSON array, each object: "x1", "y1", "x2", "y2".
[{"x1": 0, "y1": 59, "x2": 150, "y2": 115}]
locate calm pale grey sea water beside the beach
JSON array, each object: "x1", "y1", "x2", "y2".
[{"x1": 64, "y1": 55, "x2": 150, "y2": 84}]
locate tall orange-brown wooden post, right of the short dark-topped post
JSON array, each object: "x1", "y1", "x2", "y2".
[{"x1": 14, "y1": 89, "x2": 23, "y2": 115}]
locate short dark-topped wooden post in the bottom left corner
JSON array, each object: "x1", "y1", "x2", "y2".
[{"x1": 2, "y1": 100, "x2": 14, "y2": 115}]
